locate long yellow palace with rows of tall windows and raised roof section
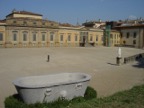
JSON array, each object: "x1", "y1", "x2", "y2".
[{"x1": 0, "y1": 11, "x2": 120, "y2": 48}]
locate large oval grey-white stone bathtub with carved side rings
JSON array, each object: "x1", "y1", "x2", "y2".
[{"x1": 13, "y1": 73, "x2": 91, "y2": 104}]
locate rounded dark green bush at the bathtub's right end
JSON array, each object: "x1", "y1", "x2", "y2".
[{"x1": 84, "y1": 87, "x2": 97, "y2": 100}]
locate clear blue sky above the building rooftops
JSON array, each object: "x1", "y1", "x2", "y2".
[{"x1": 0, "y1": 0, "x2": 144, "y2": 25}]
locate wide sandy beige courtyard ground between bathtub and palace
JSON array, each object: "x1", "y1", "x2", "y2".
[{"x1": 0, "y1": 47, "x2": 144, "y2": 108}]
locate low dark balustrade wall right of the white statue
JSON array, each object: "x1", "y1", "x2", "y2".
[{"x1": 124, "y1": 53, "x2": 144, "y2": 64}]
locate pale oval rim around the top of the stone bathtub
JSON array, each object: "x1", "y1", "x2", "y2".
[{"x1": 12, "y1": 72, "x2": 91, "y2": 89}]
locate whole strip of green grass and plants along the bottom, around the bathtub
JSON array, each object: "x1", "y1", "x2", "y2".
[{"x1": 5, "y1": 85, "x2": 144, "y2": 108}]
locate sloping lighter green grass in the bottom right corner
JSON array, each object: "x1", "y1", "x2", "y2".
[{"x1": 69, "y1": 85, "x2": 144, "y2": 108}]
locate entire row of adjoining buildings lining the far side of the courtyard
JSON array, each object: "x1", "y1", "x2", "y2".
[{"x1": 0, "y1": 10, "x2": 144, "y2": 48}]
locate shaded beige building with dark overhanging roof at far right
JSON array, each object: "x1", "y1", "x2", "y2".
[{"x1": 116, "y1": 24, "x2": 144, "y2": 48}]
